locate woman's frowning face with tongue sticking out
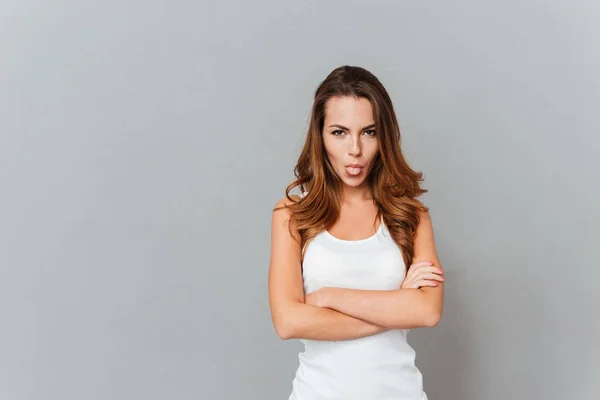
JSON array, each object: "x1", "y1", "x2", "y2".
[{"x1": 323, "y1": 96, "x2": 379, "y2": 187}]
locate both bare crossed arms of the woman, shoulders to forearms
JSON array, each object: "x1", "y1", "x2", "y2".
[{"x1": 269, "y1": 198, "x2": 444, "y2": 340}]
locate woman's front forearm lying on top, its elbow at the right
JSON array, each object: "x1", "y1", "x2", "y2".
[{"x1": 323, "y1": 288, "x2": 436, "y2": 329}]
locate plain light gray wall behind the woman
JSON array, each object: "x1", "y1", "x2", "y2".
[{"x1": 0, "y1": 0, "x2": 600, "y2": 400}]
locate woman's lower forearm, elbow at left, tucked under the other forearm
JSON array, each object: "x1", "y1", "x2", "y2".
[{"x1": 285, "y1": 303, "x2": 388, "y2": 340}]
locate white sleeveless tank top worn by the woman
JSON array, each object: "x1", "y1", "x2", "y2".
[{"x1": 288, "y1": 192, "x2": 427, "y2": 400}]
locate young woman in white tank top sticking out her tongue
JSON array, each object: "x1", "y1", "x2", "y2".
[{"x1": 269, "y1": 66, "x2": 444, "y2": 400}]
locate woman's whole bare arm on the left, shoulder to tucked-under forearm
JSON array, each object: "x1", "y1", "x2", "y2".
[{"x1": 268, "y1": 197, "x2": 388, "y2": 340}]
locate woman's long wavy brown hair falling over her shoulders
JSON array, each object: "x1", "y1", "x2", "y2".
[{"x1": 274, "y1": 65, "x2": 429, "y2": 269}]
